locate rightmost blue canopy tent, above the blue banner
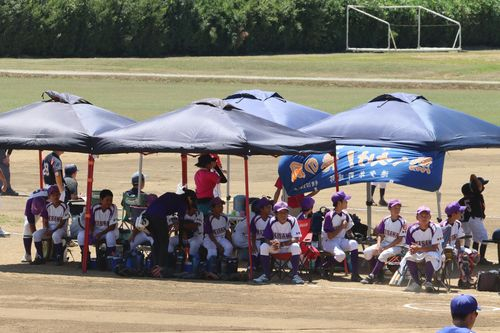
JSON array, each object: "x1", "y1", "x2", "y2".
[{"x1": 294, "y1": 93, "x2": 500, "y2": 227}]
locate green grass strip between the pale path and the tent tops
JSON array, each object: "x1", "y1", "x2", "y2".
[{"x1": 0, "y1": 77, "x2": 500, "y2": 125}]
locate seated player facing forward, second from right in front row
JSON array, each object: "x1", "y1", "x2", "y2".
[{"x1": 403, "y1": 206, "x2": 443, "y2": 292}]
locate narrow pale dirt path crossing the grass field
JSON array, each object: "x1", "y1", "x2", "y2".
[{"x1": 0, "y1": 69, "x2": 500, "y2": 88}]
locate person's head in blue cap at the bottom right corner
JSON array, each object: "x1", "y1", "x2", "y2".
[{"x1": 437, "y1": 294, "x2": 481, "y2": 333}]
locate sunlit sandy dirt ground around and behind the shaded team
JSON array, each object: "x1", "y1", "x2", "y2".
[{"x1": 0, "y1": 149, "x2": 500, "y2": 332}]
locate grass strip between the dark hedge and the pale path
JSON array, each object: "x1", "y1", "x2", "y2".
[{"x1": 0, "y1": 51, "x2": 500, "y2": 81}]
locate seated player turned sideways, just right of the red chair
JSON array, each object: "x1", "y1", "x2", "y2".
[{"x1": 321, "y1": 191, "x2": 361, "y2": 282}]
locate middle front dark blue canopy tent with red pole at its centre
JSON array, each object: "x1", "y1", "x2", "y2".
[{"x1": 94, "y1": 99, "x2": 335, "y2": 274}]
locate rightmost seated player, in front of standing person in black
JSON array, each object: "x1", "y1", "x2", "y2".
[{"x1": 440, "y1": 201, "x2": 478, "y2": 288}]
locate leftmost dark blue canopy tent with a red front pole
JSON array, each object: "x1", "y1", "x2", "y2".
[{"x1": 0, "y1": 91, "x2": 135, "y2": 268}]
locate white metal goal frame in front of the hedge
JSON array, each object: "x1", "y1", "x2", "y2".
[{"x1": 346, "y1": 5, "x2": 462, "y2": 52}]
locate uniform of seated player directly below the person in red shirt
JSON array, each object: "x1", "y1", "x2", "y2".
[{"x1": 203, "y1": 214, "x2": 233, "y2": 259}]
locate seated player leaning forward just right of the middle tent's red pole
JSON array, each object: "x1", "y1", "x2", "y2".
[{"x1": 253, "y1": 201, "x2": 304, "y2": 284}]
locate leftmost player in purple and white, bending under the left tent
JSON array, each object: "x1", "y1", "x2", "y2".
[{"x1": 21, "y1": 189, "x2": 47, "y2": 262}]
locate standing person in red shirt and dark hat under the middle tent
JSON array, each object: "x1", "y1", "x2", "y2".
[{"x1": 194, "y1": 154, "x2": 227, "y2": 216}]
